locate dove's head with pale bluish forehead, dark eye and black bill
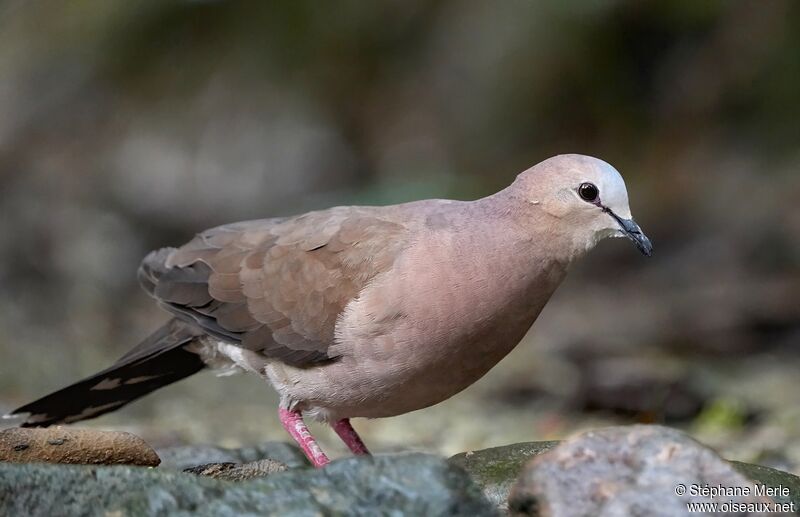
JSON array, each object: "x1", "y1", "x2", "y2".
[{"x1": 515, "y1": 154, "x2": 653, "y2": 257}]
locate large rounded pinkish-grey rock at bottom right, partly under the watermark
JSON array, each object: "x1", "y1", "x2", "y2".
[{"x1": 509, "y1": 425, "x2": 772, "y2": 517}]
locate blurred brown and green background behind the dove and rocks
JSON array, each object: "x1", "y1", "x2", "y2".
[{"x1": 0, "y1": 0, "x2": 800, "y2": 472}]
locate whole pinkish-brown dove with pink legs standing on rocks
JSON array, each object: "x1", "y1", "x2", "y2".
[{"x1": 7, "y1": 154, "x2": 653, "y2": 467}]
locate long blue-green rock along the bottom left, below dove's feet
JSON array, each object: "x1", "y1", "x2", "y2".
[{"x1": 0, "y1": 454, "x2": 495, "y2": 517}]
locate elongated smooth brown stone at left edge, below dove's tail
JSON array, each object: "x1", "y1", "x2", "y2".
[{"x1": 0, "y1": 426, "x2": 161, "y2": 467}]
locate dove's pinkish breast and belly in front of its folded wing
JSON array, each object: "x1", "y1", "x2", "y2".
[{"x1": 322, "y1": 232, "x2": 563, "y2": 417}]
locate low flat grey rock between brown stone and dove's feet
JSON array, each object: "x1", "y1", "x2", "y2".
[{"x1": 158, "y1": 442, "x2": 309, "y2": 470}]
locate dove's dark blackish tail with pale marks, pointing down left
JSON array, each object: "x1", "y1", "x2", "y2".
[{"x1": 6, "y1": 319, "x2": 205, "y2": 427}]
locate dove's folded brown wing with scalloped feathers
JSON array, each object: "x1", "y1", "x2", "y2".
[{"x1": 139, "y1": 207, "x2": 409, "y2": 367}]
